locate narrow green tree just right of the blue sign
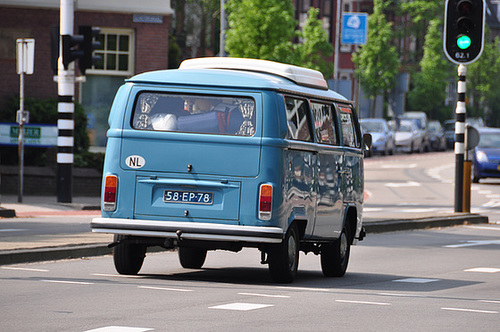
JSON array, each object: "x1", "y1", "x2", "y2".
[{"x1": 352, "y1": 0, "x2": 399, "y2": 117}]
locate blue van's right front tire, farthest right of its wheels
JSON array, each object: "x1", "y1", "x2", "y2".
[{"x1": 321, "y1": 227, "x2": 351, "y2": 277}]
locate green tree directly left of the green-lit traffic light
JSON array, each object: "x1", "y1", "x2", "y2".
[{"x1": 408, "y1": 18, "x2": 453, "y2": 118}]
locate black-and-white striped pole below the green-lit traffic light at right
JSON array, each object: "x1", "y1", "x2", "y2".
[{"x1": 455, "y1": 65, "x2": 467, "y2": 212}]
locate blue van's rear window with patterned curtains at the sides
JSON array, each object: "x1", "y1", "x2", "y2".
[{"x1": 132, "y1": 92, "x2": 255, "y2": 136}]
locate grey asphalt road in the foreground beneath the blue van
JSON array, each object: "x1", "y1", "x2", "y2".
[{"x1": 0, "y1": 225, "x2": 500, "y2": 332}]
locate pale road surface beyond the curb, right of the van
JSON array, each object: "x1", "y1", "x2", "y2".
[{"x1": 364, "y1": 152, "x2": 500, "y2": 222}]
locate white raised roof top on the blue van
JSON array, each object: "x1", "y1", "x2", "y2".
[{"x1": 179, "y1": 57, "x2": 328, "y2": 90}]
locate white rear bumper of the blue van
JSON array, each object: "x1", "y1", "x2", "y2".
[{"x1": 91, "y1": 218, "x2": 284, "y2": 243}]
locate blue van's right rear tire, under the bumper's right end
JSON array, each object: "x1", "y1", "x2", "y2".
[{"x1": 268, "y1": 224, "x2": 300, "y2": 283}]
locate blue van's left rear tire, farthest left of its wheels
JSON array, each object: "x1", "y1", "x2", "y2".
[{"x1": 113, "y1": 235, "x2": 146, "y2": 275}]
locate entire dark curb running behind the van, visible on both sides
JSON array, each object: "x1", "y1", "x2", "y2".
[{"x1": 0, "y1": 214, "x2": 488, "y2": 265}]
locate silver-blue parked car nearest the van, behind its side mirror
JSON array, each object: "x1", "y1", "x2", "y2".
[{"x1": 360, "y1": 119, "x2": 396, "y2": 155}]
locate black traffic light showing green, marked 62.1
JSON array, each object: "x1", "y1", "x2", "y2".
[{"x1": 443, "y1": 0, "x2": 486, "y2": 64}]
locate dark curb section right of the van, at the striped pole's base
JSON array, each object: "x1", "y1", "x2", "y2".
[{"x1": 363, "y1": 214, "x2": 488, "y2": 234}]
